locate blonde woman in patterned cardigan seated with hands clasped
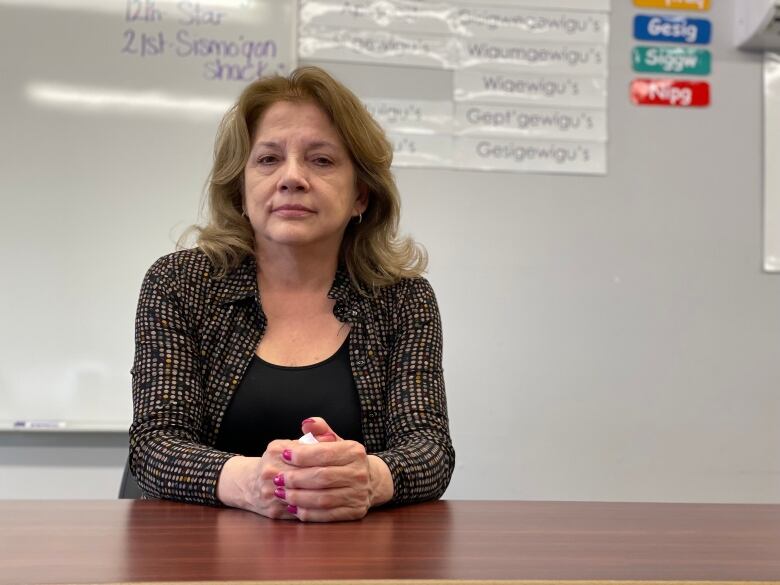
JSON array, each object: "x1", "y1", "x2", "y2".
[{"x1": 130, "y1": 67, "x2": 455, "y2": 522}]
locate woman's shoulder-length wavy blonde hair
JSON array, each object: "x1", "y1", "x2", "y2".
[{"x1": 180, "y1": 67, "x2": 428, "y2": 295}]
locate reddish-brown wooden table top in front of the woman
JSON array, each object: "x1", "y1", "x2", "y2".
[{"x1": 0, "y1": 500, "x2": 780, "y2": 585}]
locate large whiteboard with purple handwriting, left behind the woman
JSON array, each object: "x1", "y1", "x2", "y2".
[{"x1": 0, "y1": 0, "x2": 296, "y2": 430}]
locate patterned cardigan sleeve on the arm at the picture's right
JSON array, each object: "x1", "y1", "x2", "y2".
[{"x1": 375, "y1": 278, "x2": 455, "y2": 504}]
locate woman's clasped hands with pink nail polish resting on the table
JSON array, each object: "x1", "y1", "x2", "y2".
[{"x1": 217, "y1": 418, "x2": 393, "y2": 522}]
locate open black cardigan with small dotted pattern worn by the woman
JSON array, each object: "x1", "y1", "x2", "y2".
[{"x1": 130, "y1": 248, "x2": 455, "y2": 505}]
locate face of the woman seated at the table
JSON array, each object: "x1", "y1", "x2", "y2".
[{"x1": 244, "y1": 102, "x2": 367, "y2": 250}]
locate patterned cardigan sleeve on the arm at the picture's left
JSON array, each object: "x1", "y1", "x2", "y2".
[{"x1": 130, "y1": 254, "x2": 232, "y2": 505}]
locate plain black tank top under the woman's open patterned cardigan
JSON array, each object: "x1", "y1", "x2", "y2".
[{"x1": 215, "y1": 337, "x2": 363, "y2": 457}]
